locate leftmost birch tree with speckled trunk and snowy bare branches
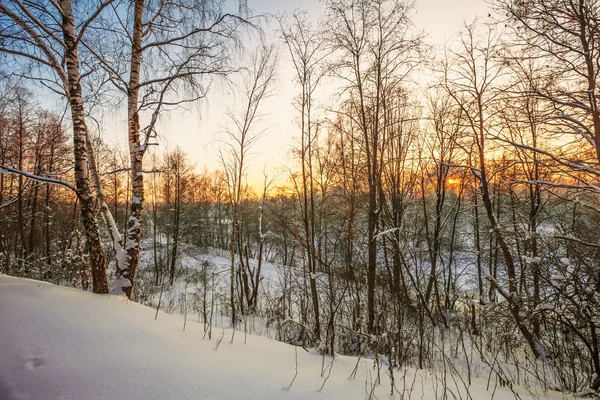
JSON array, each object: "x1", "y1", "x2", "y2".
[{"x1": 0, "y1": 0, "x2": 113, "y2": 293}]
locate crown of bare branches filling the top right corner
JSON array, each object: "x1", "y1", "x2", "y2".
[{"x1": 496, "y1": 0, "x2": 600, "y2": 175}]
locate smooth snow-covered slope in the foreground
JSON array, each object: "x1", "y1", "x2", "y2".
[{"x1": 0, "y1": 275, "x2": 572, "y2": 400}]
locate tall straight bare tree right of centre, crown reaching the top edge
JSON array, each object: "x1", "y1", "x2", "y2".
[{"x1": 325, "y1": 0, "x2": 421, "y2": 333}]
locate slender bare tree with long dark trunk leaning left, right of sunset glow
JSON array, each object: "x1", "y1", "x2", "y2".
[{"x1": 444, "y1": 24, "x2": 544, "y2": 358}]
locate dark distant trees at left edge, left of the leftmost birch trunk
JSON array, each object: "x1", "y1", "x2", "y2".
[{"x1": 0, "y1": 86, "x2": 80, "y2": 282}]
